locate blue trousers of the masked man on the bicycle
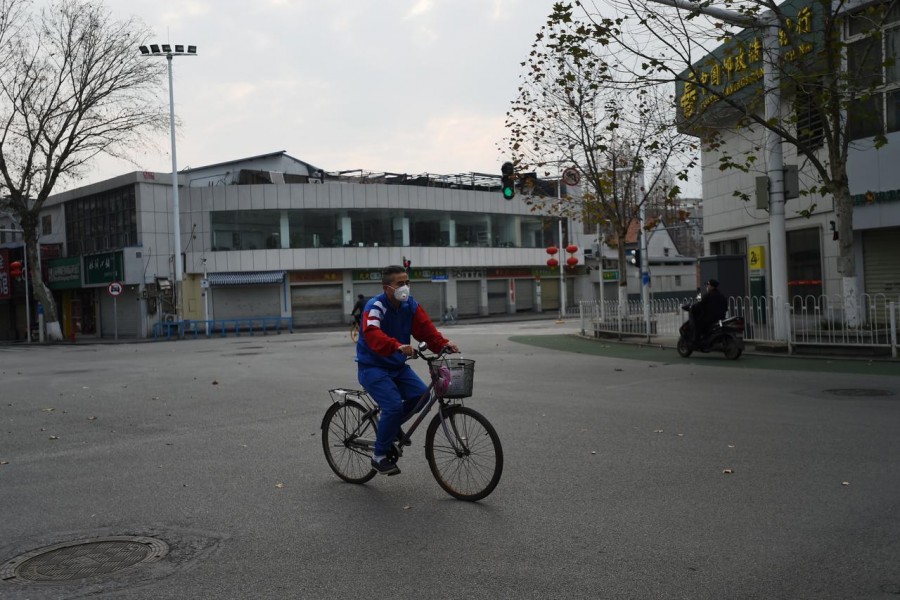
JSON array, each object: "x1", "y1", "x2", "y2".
[{"x1": 357, "y1": 365, "x2": 428, "y2": 455}]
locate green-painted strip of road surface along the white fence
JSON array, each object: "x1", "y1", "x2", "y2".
[{"x1": 509, "y1": 334, "x2": 900, "y2": 376}]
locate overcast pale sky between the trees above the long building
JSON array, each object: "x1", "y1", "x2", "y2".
[{"x1": 80, "y1": 0, "x2": 552, "y2": 185}]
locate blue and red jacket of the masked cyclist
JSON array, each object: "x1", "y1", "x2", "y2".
[{"x1": 356, "y1": 294, "x2": 450, "y2": 369}]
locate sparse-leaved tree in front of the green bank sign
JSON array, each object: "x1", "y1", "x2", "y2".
[{"x1": 551, "y1": 0, "x2": 897, "y2": 326}]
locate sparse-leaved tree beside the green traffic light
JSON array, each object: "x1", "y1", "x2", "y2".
[{"x1": 505, "y1": 15, "x2": 697, "y2": 308}]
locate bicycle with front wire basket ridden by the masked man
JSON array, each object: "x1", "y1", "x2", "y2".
[{"x1": 322, "y1": 343, "x2": 503, "y2": 502}]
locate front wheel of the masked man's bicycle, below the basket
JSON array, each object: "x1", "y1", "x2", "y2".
[{"x1": 425, "y1": 406, "x2": 503, "y2": 502}]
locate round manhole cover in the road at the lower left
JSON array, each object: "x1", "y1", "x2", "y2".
[{"x1": 0, "y1": 536, "x2": 169, "y2": 583}]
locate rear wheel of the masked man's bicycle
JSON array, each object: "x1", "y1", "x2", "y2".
[{"x1": 322, "y1": 400, "x2": 377, "y2": 483}]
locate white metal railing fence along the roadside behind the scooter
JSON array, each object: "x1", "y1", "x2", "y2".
[{"x1": 580, "y1": 294, "x2": 900, "y2": 358}]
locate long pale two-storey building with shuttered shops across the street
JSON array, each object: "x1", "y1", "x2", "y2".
[{"x1": 0, "y1": 152, "x2": 695, "y2": 337}]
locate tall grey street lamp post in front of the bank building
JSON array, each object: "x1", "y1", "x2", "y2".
[{"x1": 652, "y1": 0, "x2": 788, "y2": 341}]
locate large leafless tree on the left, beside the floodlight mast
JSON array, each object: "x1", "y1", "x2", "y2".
[{"x1": 0, "y1": 0, "x2": 168, "y2": 339}]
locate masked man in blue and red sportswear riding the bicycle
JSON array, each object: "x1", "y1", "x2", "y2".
[{"x1": 356, "y1": 265, "x2": 459, "y2": 475}]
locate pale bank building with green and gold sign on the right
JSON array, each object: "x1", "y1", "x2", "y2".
[{"x1": 678, "y1": 0, "x2": 900, "y2": 308}]
